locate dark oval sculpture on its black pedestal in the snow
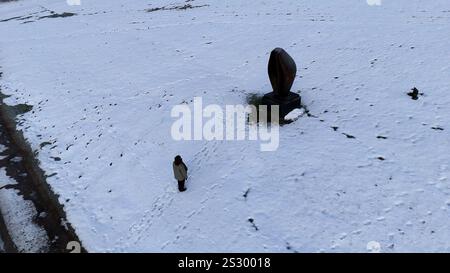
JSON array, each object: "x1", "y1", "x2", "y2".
[{"x1": 262, "y1": 48, "x2": 301, "y2": 118}]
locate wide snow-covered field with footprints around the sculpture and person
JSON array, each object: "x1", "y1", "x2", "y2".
[{"x1": 0, "y1": 0, "x2": 450, "y2": 252}]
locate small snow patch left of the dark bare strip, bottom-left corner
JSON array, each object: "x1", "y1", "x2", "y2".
[{"x1": 0, "y1": 168, "x2": 48, "y2": 253}]
